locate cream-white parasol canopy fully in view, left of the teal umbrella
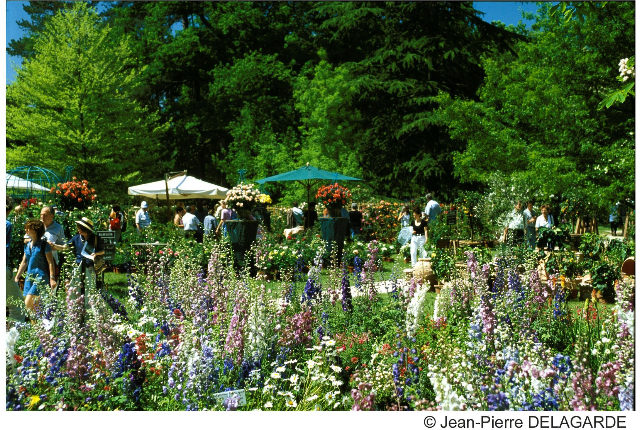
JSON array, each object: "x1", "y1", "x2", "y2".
[{"x1": 128, "y1": 175, "x2": 229, "y2": 200}]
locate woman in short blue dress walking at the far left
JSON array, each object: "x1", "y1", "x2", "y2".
[{"x1": 15, "y1": 219, "x2": 57, "y2": 312}]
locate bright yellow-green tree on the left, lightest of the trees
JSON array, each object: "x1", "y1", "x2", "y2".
[{"x1": 7, "y1": 3, "x2": 170, "y2": 201}]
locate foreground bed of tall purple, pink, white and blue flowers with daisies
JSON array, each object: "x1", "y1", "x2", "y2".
[{"x1": 6, "y1": 237, "x2": 634, "y2": 410}]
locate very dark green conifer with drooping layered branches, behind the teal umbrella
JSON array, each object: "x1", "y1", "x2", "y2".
[{"x1": 302, "y1": 2, "x2": 519, "y2": 198}]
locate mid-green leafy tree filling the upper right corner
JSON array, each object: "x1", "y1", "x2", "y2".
[{"x1": 437, "y1": 3, "x2": 635, "y2": 207}]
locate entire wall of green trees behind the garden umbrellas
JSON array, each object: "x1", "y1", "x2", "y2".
[{"x1": 7, "y1": 2, "x2": 634, "y2": 208}]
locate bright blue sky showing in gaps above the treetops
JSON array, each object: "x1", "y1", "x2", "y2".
[{"x1": 3, "y1": 1, "x2": 537, "y2": 84}]
